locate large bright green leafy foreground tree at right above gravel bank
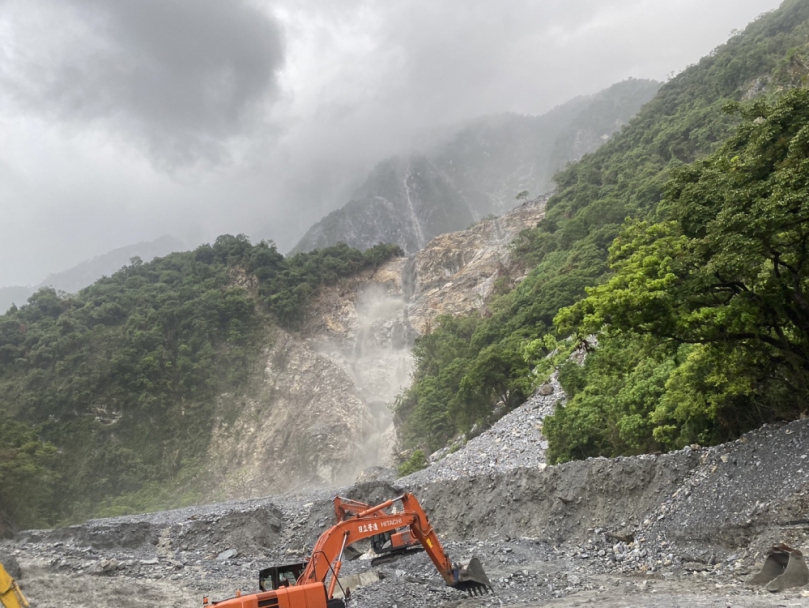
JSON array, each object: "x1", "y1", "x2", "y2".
[{"x1": 550, "y1": 89, "x2": 809, "y2": 458}]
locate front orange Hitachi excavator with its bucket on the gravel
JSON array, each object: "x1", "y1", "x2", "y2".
[{"x1": 202, "y1": 492, "x2": 492, "y2": 608}]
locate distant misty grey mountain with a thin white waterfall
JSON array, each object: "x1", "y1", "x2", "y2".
[{"x1": 294, "y1": 79, "x2": 660, "y2": 254}]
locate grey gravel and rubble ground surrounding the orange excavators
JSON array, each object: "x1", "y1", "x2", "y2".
[{"x1": 0, "y1": 392, "x2": 809, "y2": 608}]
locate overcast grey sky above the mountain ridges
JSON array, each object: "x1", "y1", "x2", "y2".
[{"x1": 0, "y1": 0, "x2": 779, "y2": 286}]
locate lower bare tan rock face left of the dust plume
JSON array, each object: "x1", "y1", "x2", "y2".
[{"x1": 209, "y1": 332, "x2": 373, "y2": 497}]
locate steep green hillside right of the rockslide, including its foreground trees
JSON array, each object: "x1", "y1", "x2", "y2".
[{"x1": 397, "y1": 0, "x2": 809, "y2": 460}]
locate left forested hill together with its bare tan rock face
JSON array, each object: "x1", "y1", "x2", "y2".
[{"x1": 0, "y1": 235, "x2": 401, "y2": 526}]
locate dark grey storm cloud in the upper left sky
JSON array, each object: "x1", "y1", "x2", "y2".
[{"x1": 0, "y1": 0, "x2": 283, "y2": 165}]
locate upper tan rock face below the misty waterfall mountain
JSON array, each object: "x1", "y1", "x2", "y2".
[{"x1": 305, "y1": 197, "x2": 547, "y2": 360}]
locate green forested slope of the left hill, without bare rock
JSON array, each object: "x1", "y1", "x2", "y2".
[{"x1": 0, "y1": 236, "x2": 401, "y2": 526}]
